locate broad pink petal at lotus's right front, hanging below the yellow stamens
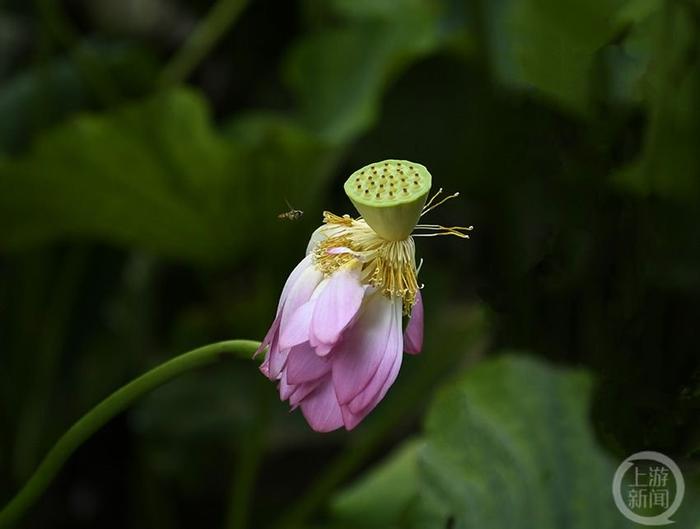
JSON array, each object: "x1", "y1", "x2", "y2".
[{"x1": 331, "y1": 293, "x2": 395, "y2": 404}]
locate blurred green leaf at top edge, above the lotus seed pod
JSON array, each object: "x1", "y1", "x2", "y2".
[{"x1": 285, "y1": 0, "x2": 445, "y2": 143}]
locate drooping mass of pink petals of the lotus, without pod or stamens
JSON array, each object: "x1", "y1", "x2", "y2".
[{"x1": 264, "y1": 218, "x2": 423, "y2": 432}]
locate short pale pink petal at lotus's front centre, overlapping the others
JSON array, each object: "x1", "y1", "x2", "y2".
[{"x1": 311, "y1": 267, "x2": 366, "y2": 345}]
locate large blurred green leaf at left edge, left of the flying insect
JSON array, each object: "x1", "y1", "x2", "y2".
[{"x1": 0, "y1": 90, "x2": 232, "y2": 261}]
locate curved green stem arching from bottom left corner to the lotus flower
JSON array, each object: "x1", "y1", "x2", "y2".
[{"x1": 0, "y1": 340, "x2": 260, "y2": 528}]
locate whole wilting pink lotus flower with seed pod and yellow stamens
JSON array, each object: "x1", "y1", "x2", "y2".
[{"x1": 259, "y1": 160, "x2": 471, "y2": 432}]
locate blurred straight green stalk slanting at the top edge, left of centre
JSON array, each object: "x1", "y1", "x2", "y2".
[{"x1": 160, "y1": 0, "x2": 248, "y2": 85}]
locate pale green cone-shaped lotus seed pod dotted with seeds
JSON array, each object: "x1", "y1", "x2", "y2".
[{"x1": 344, "y1": 160, "x2": 433, "y2": 241}]
